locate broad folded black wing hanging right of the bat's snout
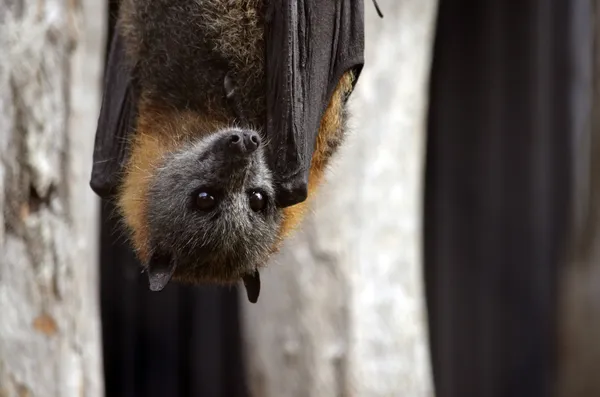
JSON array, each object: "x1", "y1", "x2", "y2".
[{"x1": 265, "y1": 0, "x2": 364, "y2": 207}]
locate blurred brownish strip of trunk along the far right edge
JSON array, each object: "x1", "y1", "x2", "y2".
[{"x1": 558, "y1": 0, "x2": 600, "y2": 397}]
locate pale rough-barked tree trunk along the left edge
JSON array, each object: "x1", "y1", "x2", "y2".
[{"x1": 0, "y1": 0, "x2": 106, "y2": 397}]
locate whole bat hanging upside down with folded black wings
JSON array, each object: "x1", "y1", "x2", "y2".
[{"x1": 90, "y1": 0, "x2": 378, "y2": 302}]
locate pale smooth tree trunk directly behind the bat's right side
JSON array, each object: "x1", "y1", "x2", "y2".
[{"x1": 242, "y1": 0, "x2": 437, "y2": 397}]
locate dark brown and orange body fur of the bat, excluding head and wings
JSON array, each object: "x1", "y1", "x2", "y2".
[{"x1": 118, "y1": 0, "x2": 353, "y2": 270}]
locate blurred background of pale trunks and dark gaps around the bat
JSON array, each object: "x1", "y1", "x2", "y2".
[{"x1": 0, "y1": 0, "x2": 600, "y2": 397}]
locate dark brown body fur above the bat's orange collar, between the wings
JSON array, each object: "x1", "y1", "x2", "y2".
[{"x1": 119, "y1": 0, "x2": 265, "y2": 127}]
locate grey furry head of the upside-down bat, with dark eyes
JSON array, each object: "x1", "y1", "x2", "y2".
[{"x1": 147, "y1": 128, "x2": 282, "y2": 291}]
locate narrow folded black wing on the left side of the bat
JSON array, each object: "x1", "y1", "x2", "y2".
[{"x1": 90, "y1": 27, "x2": 137, "y2": 198}]
